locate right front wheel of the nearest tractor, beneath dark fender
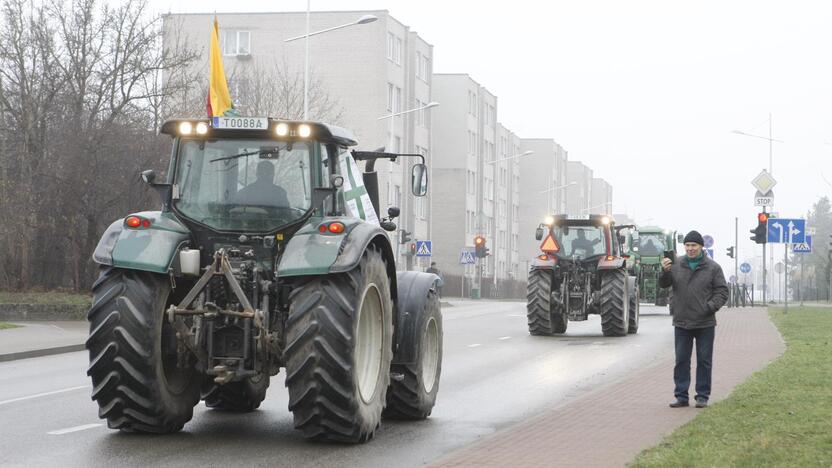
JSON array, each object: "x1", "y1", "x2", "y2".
[{"x1": 384, "y1": 283, "x2": 442, "y2": 420}]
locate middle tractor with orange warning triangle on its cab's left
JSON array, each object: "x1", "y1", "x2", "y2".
[{"x1": 526, "y1": 215, "x2": 639, "y2": 336}]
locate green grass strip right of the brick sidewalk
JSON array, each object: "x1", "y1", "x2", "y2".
[{"x1": 631, "y1": 307, "x2": 832, "y2": 467}]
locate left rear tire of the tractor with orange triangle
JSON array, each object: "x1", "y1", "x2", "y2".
[{"x1": 526, "y1": 269, "x2": 568, "y2": 336}]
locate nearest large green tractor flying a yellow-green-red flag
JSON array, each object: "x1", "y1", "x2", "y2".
[{"x1": 86, "y1": 117, "x2": 442, "y2": 443}]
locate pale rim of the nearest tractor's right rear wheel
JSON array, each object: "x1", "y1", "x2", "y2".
[{"x1": 355, "y1": 284, "x2": 384, "y2": 403}]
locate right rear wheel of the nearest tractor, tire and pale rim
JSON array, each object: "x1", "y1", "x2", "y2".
[{"x1": 284, "y1": 247, "x2": 393, "y2": 443}]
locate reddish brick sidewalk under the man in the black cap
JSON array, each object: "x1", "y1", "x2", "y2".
[{"x1": 431, "y1": 308, "x2": 785, "y2": 467}]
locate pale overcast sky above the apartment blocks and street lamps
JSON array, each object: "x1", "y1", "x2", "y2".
[{"x1": 150, "y1": 0, "x2": 832, "y2": 275}]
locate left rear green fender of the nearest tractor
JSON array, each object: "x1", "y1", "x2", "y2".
[{"x1": 92, "y1": 211, "x2": 190, "y2": 273}]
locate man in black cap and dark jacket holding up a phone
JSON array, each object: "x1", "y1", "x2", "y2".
[{"x1": 659, "y1": 231, "x2": 728, "y2": 408}]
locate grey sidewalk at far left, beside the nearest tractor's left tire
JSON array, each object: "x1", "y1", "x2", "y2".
[{"x1": 0, "y1": 320, "x2": 89, "y2": 362}]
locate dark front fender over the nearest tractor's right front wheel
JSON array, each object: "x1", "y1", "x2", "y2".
[{"x1": 393, "y1": 271, "x2": 437, "y2": 364}]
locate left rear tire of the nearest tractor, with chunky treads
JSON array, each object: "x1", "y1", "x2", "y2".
[{"x1": 86, "y1": 267, "x2": 201, "y2": 433}]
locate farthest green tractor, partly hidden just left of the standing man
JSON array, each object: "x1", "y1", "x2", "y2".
[{"x1": 627, "y1": 226, "x2": 676, "y2": 306}]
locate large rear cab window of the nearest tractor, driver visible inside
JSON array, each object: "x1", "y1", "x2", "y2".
[{"x1": 174, "y1": 139, "x2": 312, "y2": 232}]
